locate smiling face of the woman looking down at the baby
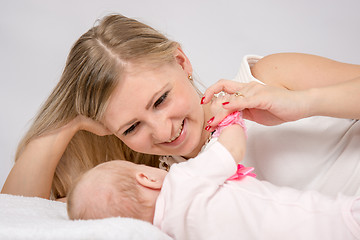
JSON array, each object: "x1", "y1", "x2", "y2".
[{"x1": 103, "y1": 50, "x2": 209, "y2": 157}]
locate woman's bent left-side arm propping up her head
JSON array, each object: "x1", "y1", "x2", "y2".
[{"x1": 1, "y1": 116, "x2": 109, "y2": 198}]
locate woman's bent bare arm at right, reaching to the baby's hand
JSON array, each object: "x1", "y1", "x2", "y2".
[{"x1": 204, "y1": 54, "x2": 360, "y2": 125}]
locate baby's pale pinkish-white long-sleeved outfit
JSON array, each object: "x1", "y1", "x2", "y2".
[{"x1": 154, "y1": 141, "x2": 360, "y2": 240}]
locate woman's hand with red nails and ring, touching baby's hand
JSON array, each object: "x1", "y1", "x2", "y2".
[{"x1": 202, "y1": 80, "x2": 309, "y2": 126}]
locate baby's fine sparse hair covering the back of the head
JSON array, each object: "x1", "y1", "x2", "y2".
[{"x1": 67, "y1": 161, "x2": 146, "y2": 220}]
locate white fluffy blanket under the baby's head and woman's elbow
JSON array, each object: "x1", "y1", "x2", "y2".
[{"x1": 0, "y1": 194, "x2": 172, "y2": 240}]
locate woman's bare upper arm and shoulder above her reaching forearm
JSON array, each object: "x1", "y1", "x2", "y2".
[{"x1": 251, "y1": 53, "x2": 360, "y2": 90}]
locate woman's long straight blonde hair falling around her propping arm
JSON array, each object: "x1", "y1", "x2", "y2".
[{"x1": 15, "y1": 14, "x2": 179, "y2": 198}]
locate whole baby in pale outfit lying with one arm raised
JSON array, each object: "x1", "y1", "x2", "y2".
[{"x1": 68, "y1": 112, "x2": 360, "y2": 240}]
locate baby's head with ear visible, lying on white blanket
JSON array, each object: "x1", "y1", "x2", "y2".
[{"x1": 67, "y1": 160, "x2": 166, "y2": 223}]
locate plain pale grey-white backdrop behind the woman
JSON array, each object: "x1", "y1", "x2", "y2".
[{"x1": 0, "y1": 0, "x2": 360, "y2": 190}]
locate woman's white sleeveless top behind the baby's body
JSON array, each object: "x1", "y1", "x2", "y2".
[{"x1": 162, "y1": 55, "x2": 360, "y2": 196}]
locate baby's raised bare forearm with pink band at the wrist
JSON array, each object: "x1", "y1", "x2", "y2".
[{"x1": 215, "y1": 112, "x2": 246, "y2": 164}]
